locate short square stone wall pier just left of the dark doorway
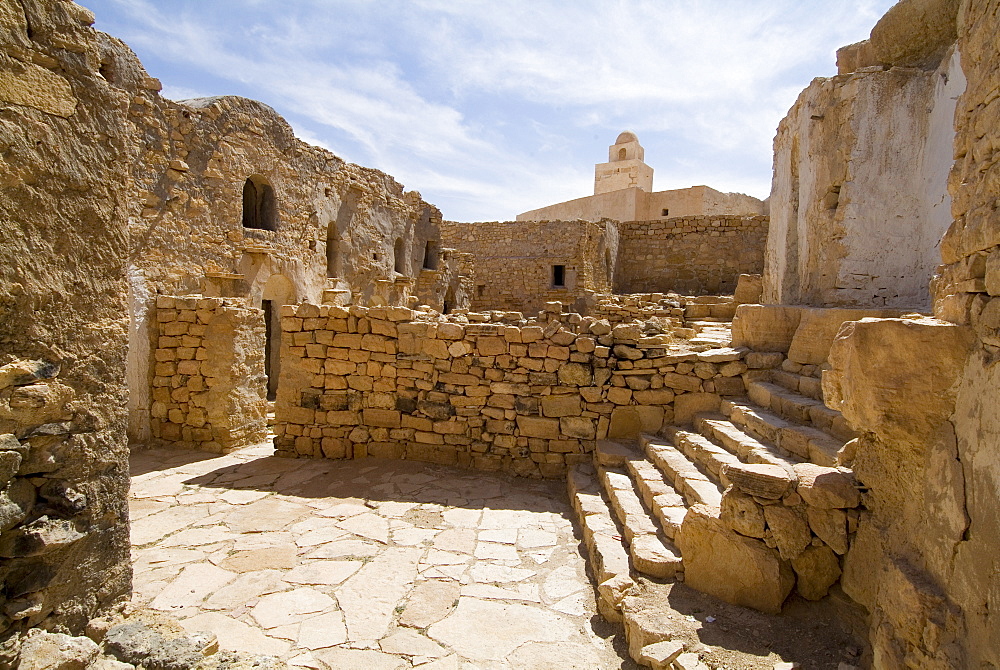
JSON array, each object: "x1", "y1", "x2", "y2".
[{"x1": 151, "y1": 295, "x2": 267, "y2": 453}]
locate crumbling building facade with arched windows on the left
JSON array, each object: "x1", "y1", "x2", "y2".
[{"x1": 88, "y1": 34, "x2": 467, "y2": 443}]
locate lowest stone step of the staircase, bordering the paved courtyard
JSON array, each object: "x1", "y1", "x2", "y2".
[{"x1": 566, "y1": 465, "x2": 634, "y2": 622}]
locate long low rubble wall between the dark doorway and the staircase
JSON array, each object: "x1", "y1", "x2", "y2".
[{"x1": 275, "y1": 304, "x2": 747, "y2": 477}]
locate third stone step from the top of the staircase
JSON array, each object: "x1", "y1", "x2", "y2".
[{"x1": 721, "y1": 399, "x2": 845, "y2": 467}]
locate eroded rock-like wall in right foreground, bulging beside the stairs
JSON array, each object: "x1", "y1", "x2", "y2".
[{"x1": 824, "y1": 0, "x2": 1000, "y2": 668}]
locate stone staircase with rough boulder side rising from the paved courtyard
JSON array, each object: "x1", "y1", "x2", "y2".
[{"x1": 569, "y1": 353, "x2": 859, "y2": 661}]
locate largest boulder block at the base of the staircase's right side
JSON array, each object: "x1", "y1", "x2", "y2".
[{"x1": 677, "y1": 505, "x2": 795, "y2": 614}]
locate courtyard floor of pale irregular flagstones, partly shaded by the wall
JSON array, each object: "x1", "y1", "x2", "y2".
[{"x1": 129, "y1": 445, "x2": 635, "y2": 670}]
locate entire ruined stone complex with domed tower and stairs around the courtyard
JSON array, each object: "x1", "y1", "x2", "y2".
[{"x1": 0, "y1": 0, "x2": 1000, "y2": 669}]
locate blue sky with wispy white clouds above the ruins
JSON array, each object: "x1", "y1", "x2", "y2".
[{"x1": 79, "y1": 0, "x2": 894, "y2": 221}]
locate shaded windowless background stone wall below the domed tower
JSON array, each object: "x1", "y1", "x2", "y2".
[{"x1": 615, "y1": 216, "x2": 768, "y2": 294}]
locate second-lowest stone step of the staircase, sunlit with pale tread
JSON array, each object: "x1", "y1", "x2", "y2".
[{"x1": 598, "y1": 467, "x2": 683, "y2": 579}]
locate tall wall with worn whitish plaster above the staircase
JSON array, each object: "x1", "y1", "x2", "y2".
[{"x1": 764, "y1": 34, "x2": 965, "y2": 311}]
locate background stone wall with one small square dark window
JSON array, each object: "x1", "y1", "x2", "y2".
[{"x1": 441, "y1": 221, "x2": 618, "y2": 314}]
